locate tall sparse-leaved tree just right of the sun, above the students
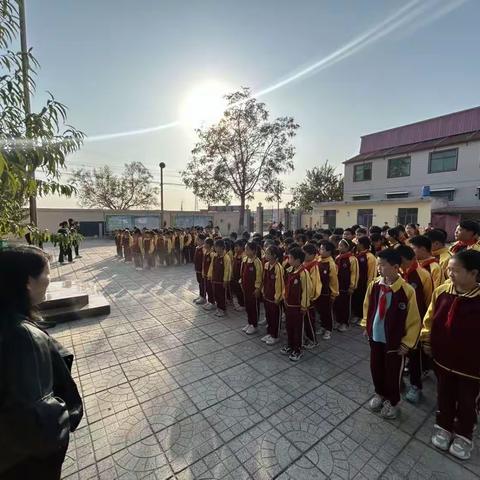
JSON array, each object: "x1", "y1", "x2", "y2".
[{"x1": 181, "y1": 88, "x2": 299, "y2": 231}]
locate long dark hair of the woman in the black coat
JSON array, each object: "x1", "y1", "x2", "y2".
[{"x1": 0, "y1": 246, "x2": 48, "y2": 317}]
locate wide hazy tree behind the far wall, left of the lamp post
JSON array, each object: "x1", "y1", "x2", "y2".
[{"x1": 72, "y1": 162, "x2": 159, "y2": 210}]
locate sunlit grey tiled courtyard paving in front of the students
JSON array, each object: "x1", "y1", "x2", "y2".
[{"x1": 47, "y1": 241, "x2": 480, "y2": 480}]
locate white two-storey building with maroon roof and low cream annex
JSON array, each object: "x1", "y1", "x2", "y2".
[{"x1": 311, "y1": 107, "x2": 480, "y2": 235}]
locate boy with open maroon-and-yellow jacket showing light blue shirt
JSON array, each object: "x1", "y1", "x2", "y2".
[{"x1": 361, "y1": 248, "x2": 421, "y2": 419}]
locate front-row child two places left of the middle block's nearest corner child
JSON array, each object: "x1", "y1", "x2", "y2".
[{"x1": 240, "y1": 241, "x2": 263, "y2": 335}]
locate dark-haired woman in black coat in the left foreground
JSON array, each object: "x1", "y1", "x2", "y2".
[{"x1": 0, "y1": 247, "x2": 83, "y2": 480}]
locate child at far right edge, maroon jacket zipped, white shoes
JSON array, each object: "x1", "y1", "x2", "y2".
[{"x1": 421, "y1": 249, "x2": 480, "y2": 460}]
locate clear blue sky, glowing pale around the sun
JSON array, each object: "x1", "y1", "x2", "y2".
[{"x1": 26, "y1": 0, "x2": 480, "y2": 210}]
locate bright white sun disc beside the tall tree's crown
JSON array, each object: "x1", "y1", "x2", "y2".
[{"x1": 180, "y1": 80, "x2": 230, "y2": 128}]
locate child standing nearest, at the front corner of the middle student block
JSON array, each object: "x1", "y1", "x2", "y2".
[{"x1": 280, "y1": 248, "x2": 312, "y2": 362}]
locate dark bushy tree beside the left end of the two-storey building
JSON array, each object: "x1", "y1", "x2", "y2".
[{"x1": 291, "y1": 160, "x2": 343, "y2": 211}]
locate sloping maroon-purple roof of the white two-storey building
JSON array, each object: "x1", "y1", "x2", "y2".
[{"x1": 345, "y1": 107, "x2": 480, "y2": 163}]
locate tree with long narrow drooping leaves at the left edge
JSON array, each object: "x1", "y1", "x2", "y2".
[{"x1": 0, "y1": 0, "x2": 84, "y2": 235}]
